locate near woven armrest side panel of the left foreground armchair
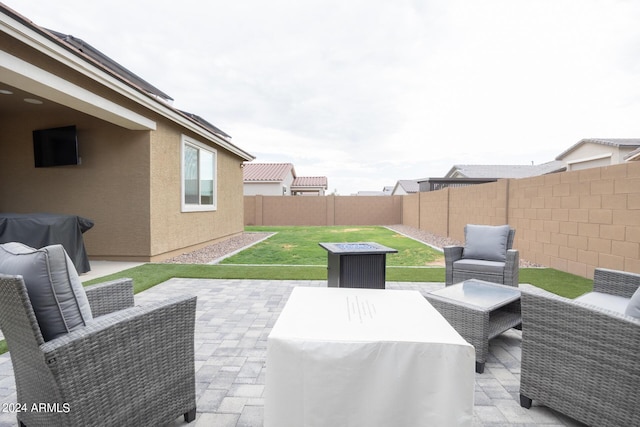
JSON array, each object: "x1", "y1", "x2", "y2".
[{"x1": 41, "y1": 297, "x2": 196, "y2": 425}]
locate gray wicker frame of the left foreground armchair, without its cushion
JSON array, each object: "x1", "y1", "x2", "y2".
[{"x1": 0, "y1": 274, "x2": 196, "y2": 427}]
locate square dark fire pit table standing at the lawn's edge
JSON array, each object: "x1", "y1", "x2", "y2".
[{"x1": 319, "y1": 242, "x2": 398, "y2": 289}]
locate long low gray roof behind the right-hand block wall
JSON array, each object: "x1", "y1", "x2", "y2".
[{"x1": 445, "y1": 160, "x2": 565, "y2": 178}]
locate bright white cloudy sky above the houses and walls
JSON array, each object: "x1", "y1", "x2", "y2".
[{"x1": 3, "y1": 0, "x2": 640, "y2": 194}]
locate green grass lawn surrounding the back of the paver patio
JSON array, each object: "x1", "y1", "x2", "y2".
[{"x1": 0, "y1": 227, "x2": 593, "y2": 354}]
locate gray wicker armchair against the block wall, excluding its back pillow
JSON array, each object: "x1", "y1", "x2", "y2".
[{"x1": 443, "y1": 225, "x2": 520, "y2": 287}]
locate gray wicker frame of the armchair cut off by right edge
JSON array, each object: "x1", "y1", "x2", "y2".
[{"x1": 520, "y1": 269, "x2": 640, "y2": 427}]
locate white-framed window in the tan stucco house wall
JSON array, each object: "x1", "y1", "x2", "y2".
[{"x1": 182, "y1": 136, "x2": 217, "y2": 212}]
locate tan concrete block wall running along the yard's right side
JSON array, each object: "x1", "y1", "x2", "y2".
[{"x1": 416, "y1": 162, "x2": 640, "y2": 278}]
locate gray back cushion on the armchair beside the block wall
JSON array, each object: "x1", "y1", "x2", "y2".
[{"x1": 462, "y1": 224, "x2": 509, "y2": 262}]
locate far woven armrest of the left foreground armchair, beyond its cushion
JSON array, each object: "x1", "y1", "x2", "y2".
[{"x1": 85, "y1": 278, "x2": 134, "y2": 317}]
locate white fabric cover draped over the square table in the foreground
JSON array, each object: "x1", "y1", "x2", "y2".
[{"x1": 264, "y1": 287, "x2": 475, "y2": 427}]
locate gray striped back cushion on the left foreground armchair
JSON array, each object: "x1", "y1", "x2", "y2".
[{"x1": 0, "y1": 242, "x2": 93, "y2": 341}]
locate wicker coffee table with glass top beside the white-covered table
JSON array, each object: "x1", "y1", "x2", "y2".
[{"x1": 425, "y1": 279, "x2": 522, "y2": 373}]
